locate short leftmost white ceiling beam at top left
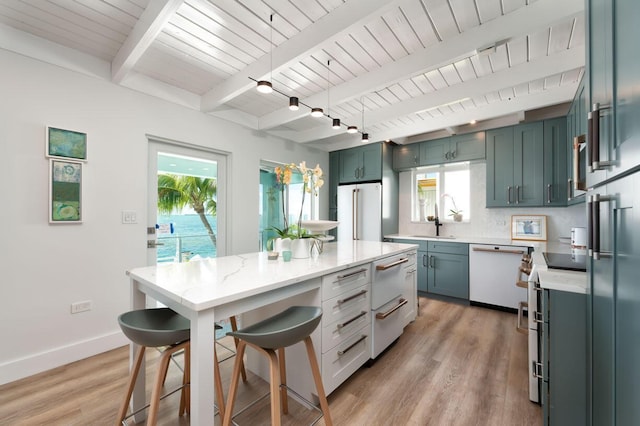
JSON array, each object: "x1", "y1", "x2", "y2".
[{"x1": 111, "y1": 0, "x2": 184, "y2": 83}]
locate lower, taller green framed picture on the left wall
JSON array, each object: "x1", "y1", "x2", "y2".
[{"x1": 49, "y1": 159, "x2": 82, "y2": 223}]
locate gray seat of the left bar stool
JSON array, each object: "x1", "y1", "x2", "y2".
[{"x1": 118, "y1": 308, "x2": 191, "y2": 348}]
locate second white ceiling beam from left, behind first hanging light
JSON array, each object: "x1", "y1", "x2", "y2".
[{"x1": 201, "y1": 0, "x2": 407, "y2": 112}]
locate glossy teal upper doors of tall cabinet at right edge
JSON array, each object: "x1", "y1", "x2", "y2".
[{"x1": 587, "y1": 0, "x2": 640, "y2": 187}]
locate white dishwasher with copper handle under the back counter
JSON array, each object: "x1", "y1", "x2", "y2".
[{"x1": 469, "y1": 244, "x2": 529, "y2": 310}]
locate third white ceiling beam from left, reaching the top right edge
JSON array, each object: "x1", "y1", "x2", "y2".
[{"x1": 260, "y1": 0, "x2": 584, "y2": 129}]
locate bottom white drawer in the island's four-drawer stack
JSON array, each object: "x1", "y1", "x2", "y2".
[{"x1": 322, "y1": 325, "x2": 371, "y2": 395}]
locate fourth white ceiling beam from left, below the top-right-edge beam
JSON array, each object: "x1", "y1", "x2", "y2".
[{"x1": 296, "y1": 48, "x2": 585, "y2": 142}]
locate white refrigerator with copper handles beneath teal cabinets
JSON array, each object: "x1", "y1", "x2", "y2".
[{"x1": 338, "y1": 183, "x2": 382, "y2": 241}]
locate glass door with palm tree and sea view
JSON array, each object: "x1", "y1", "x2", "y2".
[{"x1": 147, "y1": 140, "x2": 226, "y2": 265}]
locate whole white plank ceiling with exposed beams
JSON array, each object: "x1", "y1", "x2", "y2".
[{"x1": 0, "y1": 0, "x2": 585, "y2": 150}]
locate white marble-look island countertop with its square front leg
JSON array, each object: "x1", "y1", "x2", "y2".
[{"x1": 128, "y1": 241, "x2": 417, "y2": 425}]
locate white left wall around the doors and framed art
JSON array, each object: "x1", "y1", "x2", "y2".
[{"x1": 0, "y1": 49, "x2": 328, "y2": 384}]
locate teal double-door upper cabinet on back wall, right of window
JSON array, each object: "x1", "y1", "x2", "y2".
[{"x1": 487, "y1": 122, "x2": 544, "y2": 207}]
